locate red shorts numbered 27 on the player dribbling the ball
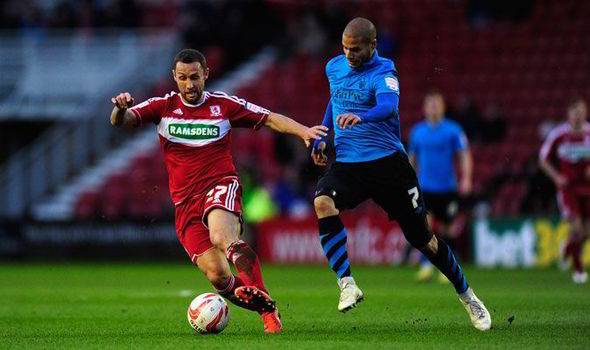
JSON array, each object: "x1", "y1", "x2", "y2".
[{"x1": 174, "y1": 176, "x2": 242, "y2": 263}]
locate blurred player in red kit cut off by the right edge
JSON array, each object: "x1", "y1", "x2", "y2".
[{"x1": 540, "y1": 99, "x2": 590, "y2": 283}]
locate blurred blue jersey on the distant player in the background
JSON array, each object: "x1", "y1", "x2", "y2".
[{"x1": 408, "y1": 119, "x2": 468, "y2": 192}]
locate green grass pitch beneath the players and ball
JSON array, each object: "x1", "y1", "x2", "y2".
[{"x1": 0, "y1": 264, "x2": 590, "y2": 350}]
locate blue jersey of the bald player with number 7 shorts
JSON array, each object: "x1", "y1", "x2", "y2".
[{"x1": 326, "y1": 50, "x2": 405, "y2": 163}]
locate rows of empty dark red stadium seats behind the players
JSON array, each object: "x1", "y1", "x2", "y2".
[{"x1": 0, "y1": 0, "x2": 590, "y2": 219}]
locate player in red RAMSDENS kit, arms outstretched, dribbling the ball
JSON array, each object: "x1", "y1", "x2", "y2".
[{"x1": 111, "y1": 49, "x2": 327, "y2": 333}]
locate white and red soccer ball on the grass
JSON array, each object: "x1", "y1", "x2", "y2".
[{"x1": 186, "y1": 293, "x2": 229, "y2": 334}]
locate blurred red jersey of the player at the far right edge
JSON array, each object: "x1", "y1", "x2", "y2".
[{"x1": 540, "y1": 123, "x2": 590, "y2": 191}]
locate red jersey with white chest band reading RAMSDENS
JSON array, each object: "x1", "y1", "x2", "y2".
[{"x1": 130, "y1": 91, "x2": 270, "y2": 205}]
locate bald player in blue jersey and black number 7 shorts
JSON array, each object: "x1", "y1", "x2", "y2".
[{"x1": 312, "y1": 18, "x2": 492, "y2": 331}]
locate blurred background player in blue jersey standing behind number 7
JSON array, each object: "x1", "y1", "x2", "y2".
[{"x1": 408, "y1": 90, "x2": 473, "y2": 283}]
